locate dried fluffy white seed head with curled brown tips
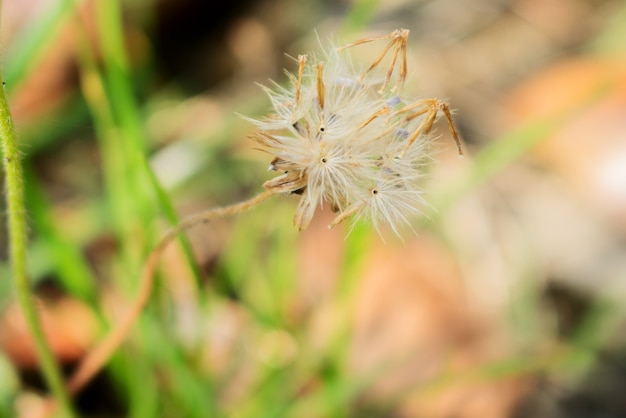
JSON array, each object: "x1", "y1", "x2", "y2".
[{"x1": 249, "y1": 29, "x2": 461, "y2": 233}]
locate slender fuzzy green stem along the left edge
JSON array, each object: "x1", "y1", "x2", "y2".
[{"x1": 0, "y1": 1, "x2": 74, "y2": 417}]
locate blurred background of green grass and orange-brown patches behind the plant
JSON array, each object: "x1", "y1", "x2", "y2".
[{"x1": 0, "y1": 0, "x2": 626, "y2": 418}]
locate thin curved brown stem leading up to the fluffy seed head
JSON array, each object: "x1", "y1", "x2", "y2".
[{"x1": 67, "y1": 191, "x2": 274, "y2": 394}]
